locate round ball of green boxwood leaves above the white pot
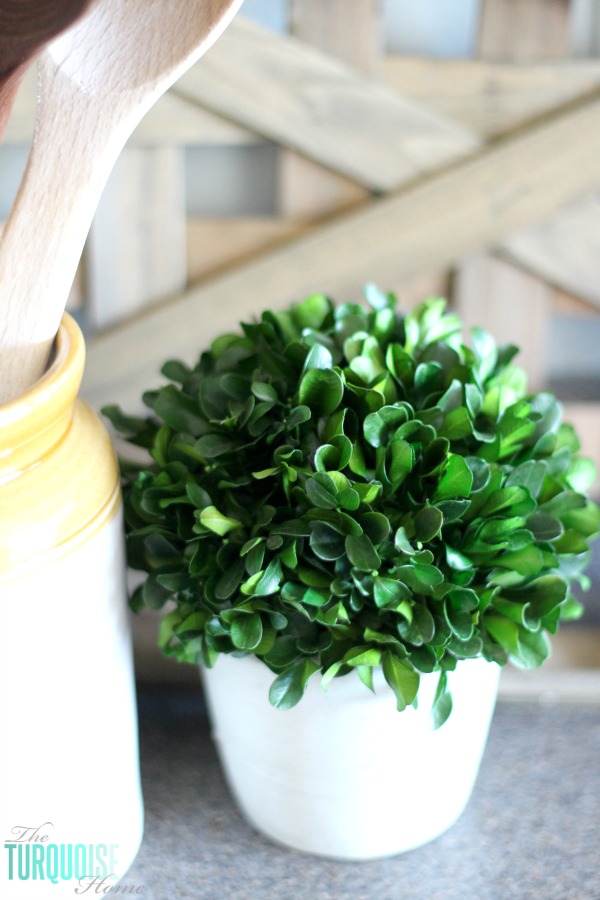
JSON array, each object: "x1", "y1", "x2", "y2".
[{"x1": 104, "y1": 286, "x2": 600, "y2": 725}]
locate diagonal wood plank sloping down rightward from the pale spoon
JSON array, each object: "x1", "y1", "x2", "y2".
[{"x1": 173, "y1": 18, "x2": 478, "y2": 191}]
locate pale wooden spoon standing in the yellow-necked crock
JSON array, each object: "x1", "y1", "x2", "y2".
[{"x1": 0, "y1": 0, "x2": 242, "y2": 402}]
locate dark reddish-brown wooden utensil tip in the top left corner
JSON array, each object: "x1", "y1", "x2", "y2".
[{"x1": 0, "y1": 0, "x2": 90, "y2": 139}]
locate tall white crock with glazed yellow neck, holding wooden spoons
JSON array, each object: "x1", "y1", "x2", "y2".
[{"x1": 0, "y1": 315, "x2": 143, "y2": 900}]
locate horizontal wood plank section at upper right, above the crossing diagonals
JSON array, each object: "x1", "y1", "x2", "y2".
[{"x1": 383, "y1": 56, "x2": 600, "y2": 138}]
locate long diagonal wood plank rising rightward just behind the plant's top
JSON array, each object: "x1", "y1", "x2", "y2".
[{"x1": 85, "y1": 89, "x2": 600, "y2": 405}]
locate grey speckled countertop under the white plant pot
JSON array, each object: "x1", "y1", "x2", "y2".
[{"x1": 123, "y1": 688, "x2": 600, "y2": 900}]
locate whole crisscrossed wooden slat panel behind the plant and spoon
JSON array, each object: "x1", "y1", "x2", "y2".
[{"x1": 0, "y1": 0, "x2": 600, "y2": 677}]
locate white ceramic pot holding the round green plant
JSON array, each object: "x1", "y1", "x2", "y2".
[{"x1": 202, "y1": 655, "x2": 499, "y2": 860}]
